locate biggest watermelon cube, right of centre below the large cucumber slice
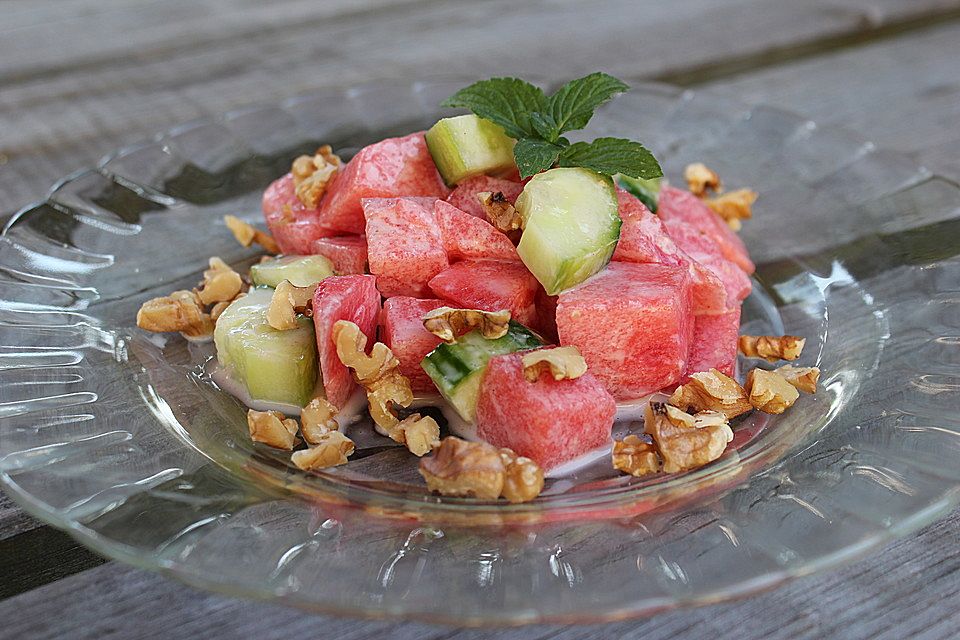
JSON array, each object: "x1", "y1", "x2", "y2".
[{"x1": 557, "y1": 262, "x2": 693, "y2": 400}]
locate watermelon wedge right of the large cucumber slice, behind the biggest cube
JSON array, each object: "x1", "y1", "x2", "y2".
[{"x1": 613, "y1": 188, "x2": 728, "y2": 313}]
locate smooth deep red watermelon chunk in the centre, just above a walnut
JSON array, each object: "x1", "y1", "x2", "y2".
[{"x1": 430, "y1": 260, "x2": 540, "y2": 327}]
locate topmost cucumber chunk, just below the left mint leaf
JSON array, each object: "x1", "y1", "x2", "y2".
[{"x1": 426, "y1": 113, "x2": 516, "y2": 187}]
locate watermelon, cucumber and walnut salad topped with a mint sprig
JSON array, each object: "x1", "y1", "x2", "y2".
[{"x1": 137, "y1": 73, "x2": 819, "y2": 502}]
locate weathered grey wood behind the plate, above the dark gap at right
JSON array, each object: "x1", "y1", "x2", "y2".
[{"x1": 0, "y1": 0, "x2": 960, "y2": 218}]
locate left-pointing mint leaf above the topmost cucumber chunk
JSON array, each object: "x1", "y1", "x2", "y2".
[{"x1": 441, "y1": 78, "x2": 547, "y2": 138}]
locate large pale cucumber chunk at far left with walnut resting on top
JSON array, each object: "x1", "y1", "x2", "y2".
[{"x1": 213, "y1": 288, "x2": 318, "y2": 407}]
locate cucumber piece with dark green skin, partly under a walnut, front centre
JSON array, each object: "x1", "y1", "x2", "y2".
[{"x1": 420, "y1": 321, "x2": 543, "y2": 422}]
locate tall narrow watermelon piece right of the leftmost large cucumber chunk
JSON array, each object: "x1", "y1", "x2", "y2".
[{"x1": 313, "y1": 275, "x2": 380, "y2": 408}]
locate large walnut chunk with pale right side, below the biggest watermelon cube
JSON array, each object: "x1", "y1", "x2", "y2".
[{"x1": 644, "y1": 402, "x2": 733, "y2": 473}]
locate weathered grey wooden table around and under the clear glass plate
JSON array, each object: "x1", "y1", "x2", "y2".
[{"x1": 0, "y1": 0, "x2": 960, "y2": 640}]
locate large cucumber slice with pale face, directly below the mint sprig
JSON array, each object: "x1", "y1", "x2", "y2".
[{"x1": 516, "y1": 168, "x2": 620, "y2": 295}]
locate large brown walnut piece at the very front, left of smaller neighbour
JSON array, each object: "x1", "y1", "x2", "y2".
[{"x1": 420, "y1": 436, "x2": 506, "y2": 500}]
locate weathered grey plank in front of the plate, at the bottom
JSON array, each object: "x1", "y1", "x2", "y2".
[{"x1": 0, "y1": 513, "x2": 960, "y2": 640}]
